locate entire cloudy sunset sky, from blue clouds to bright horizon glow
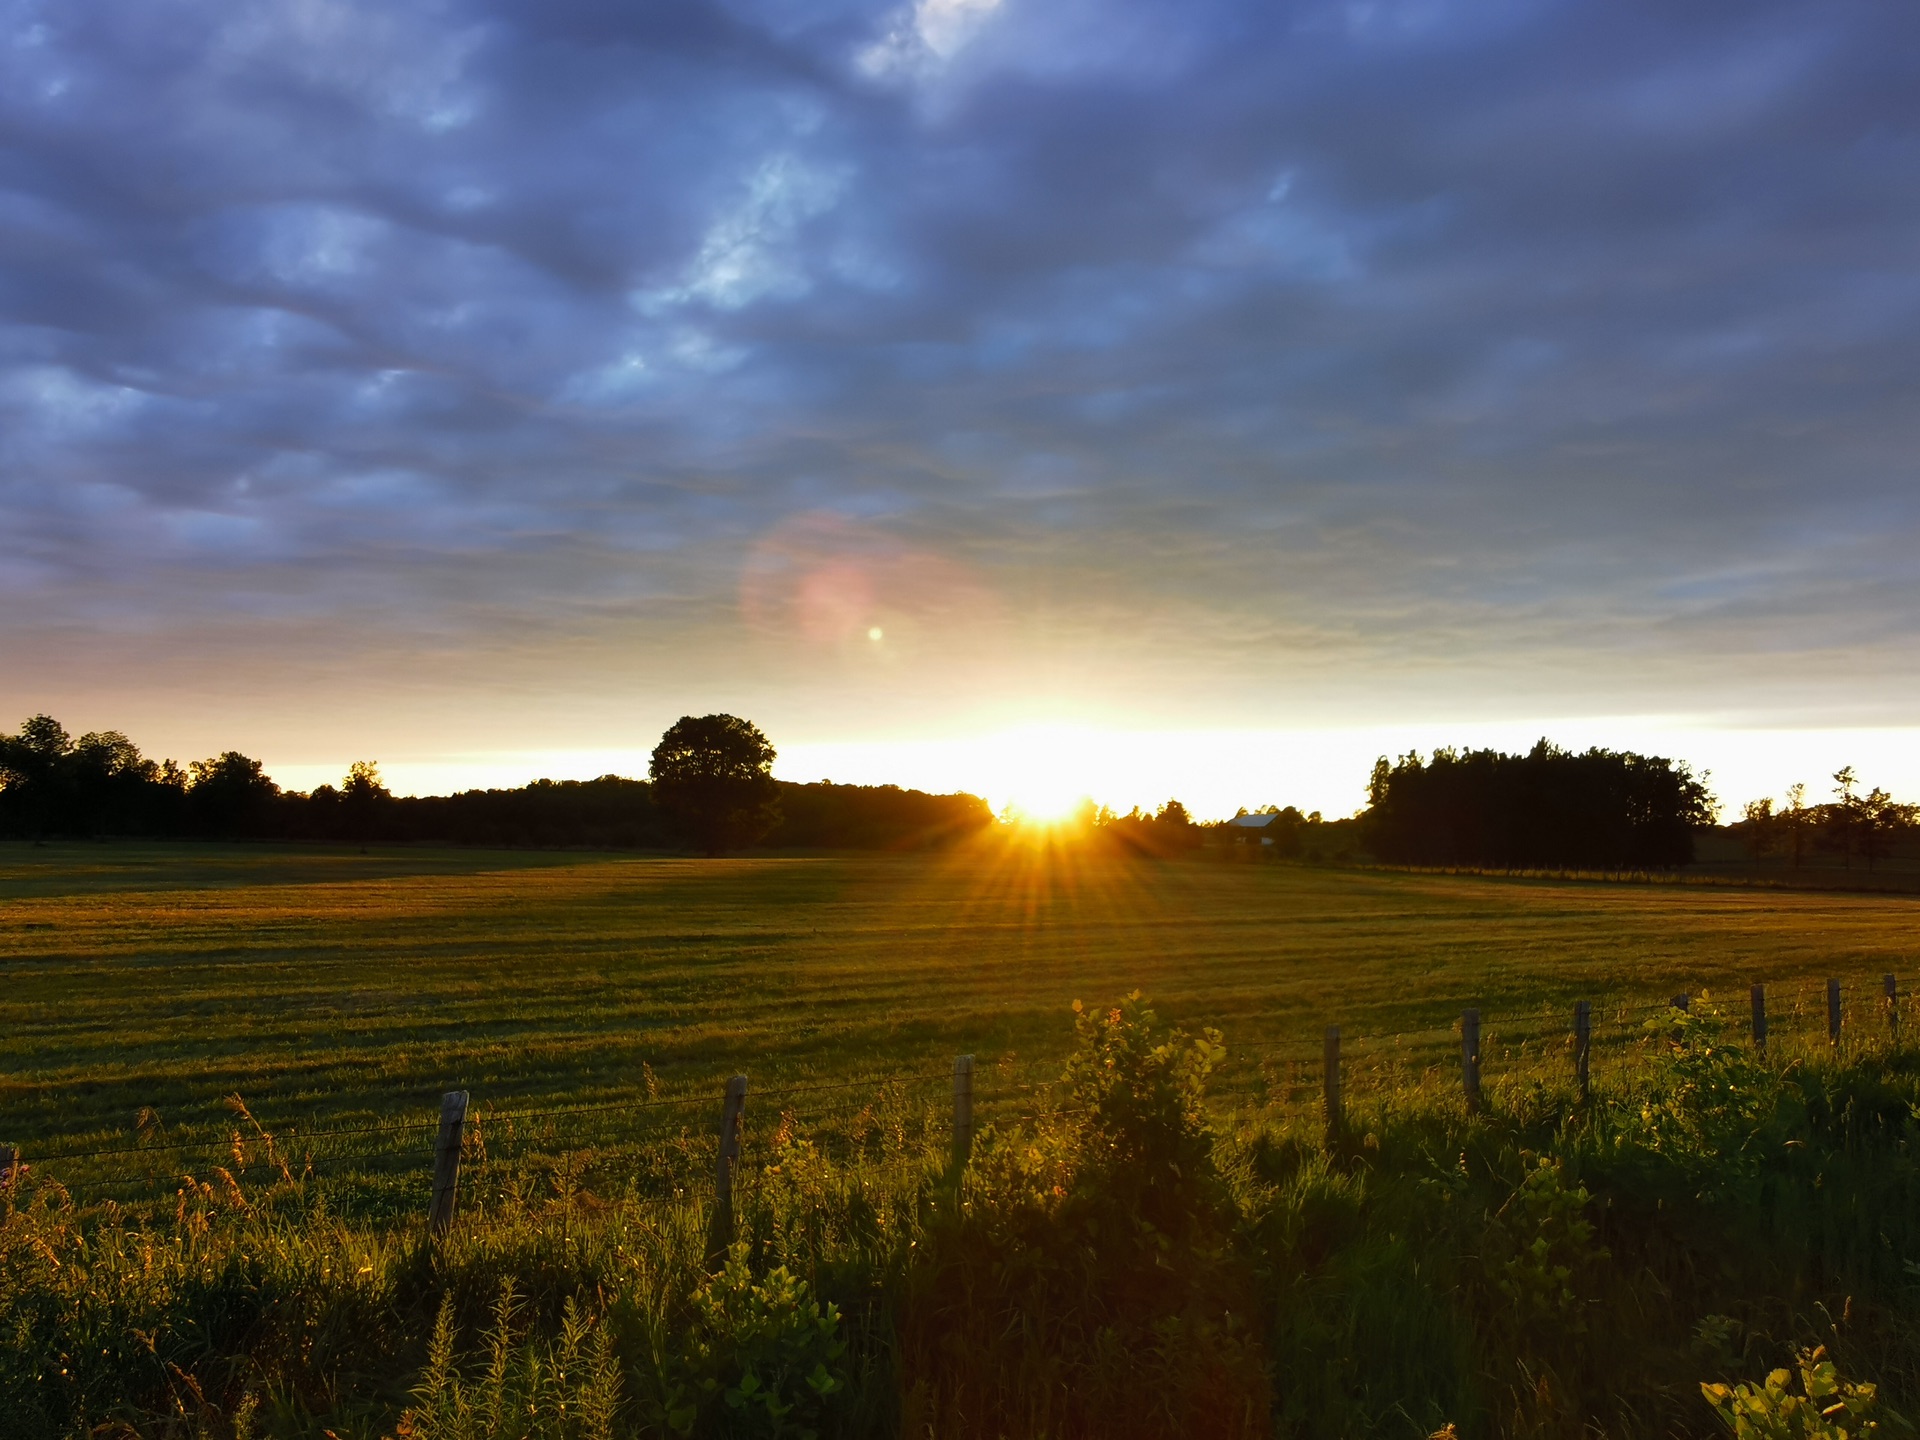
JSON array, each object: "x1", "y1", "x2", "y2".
[{"x1": 0, "y1": 0, "x2": 1920, "y2": 814}]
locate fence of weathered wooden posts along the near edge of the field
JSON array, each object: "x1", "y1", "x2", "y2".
[{"x1": 0, "y1": 975, "x2": 1903, "y2": 1212}]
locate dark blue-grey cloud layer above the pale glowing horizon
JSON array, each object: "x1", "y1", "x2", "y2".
[{"x1": 0, "y1": 0, "x2": 1920, "y2": 718}]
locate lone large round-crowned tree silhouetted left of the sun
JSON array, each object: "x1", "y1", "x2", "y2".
[{"x1": 647, "y1": 714, "x2": 780, "y2": 854}]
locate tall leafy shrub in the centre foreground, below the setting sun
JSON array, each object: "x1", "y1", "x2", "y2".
[{"x1": 900, "y1": 995, "x2": 1269, "y2": 1440}]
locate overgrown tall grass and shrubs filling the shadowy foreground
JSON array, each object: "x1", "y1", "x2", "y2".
[{"x1": 11, "y1": 998, "x2": 1920, "y2": 1440}]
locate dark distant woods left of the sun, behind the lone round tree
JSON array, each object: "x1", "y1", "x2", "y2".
[{"x1": 0, "y1": 714, "x2": 993, "y2": 851}]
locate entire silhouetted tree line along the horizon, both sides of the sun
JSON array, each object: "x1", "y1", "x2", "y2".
[{"x1": 11, "y1": 714, "x2": 1920, "y2": 870}]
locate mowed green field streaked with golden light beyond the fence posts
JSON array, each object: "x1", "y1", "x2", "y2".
[{"x1": 0, "y1": 841, "x2": 1920, "y2": 1152}]
